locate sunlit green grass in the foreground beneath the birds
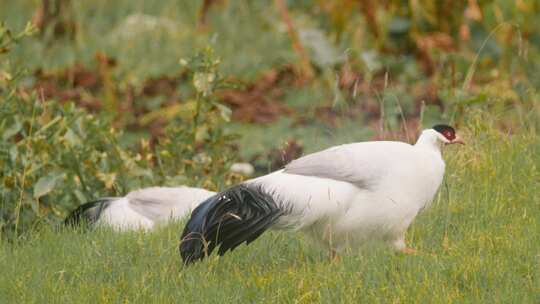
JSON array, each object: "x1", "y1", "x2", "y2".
[{"x1": 0, "y1": 116, "x2": 540, "y2": 303}]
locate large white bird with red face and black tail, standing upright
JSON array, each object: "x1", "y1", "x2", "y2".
[{"x1": 180, "y1": 125, "x2": 463, "y2": 264}]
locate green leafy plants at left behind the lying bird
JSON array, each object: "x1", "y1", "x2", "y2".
[{"x1": 0, "y1": 23, "x2": 233, "y2": 238}]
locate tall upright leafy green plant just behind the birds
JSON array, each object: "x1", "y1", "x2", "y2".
[{"x1": 156, "y1": 48, "x2": 238, "y2": 189}]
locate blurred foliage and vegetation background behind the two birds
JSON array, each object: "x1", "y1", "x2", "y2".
[{"x1": 0, "y1": 0, "x2": 540, "y2": 236}]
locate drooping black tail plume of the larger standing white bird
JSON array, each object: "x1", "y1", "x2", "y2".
[{"x1": 180, "y1": 184, "x2": 285, "y2": 265}]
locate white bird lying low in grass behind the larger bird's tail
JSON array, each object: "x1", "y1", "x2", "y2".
[{"x1": 64, "y1": 186, "x2": 216, "y2": 231}]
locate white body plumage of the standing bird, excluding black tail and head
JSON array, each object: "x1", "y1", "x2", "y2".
[{"x1": 248, "y1": 130, "x2": 445, "y2": 250}]
